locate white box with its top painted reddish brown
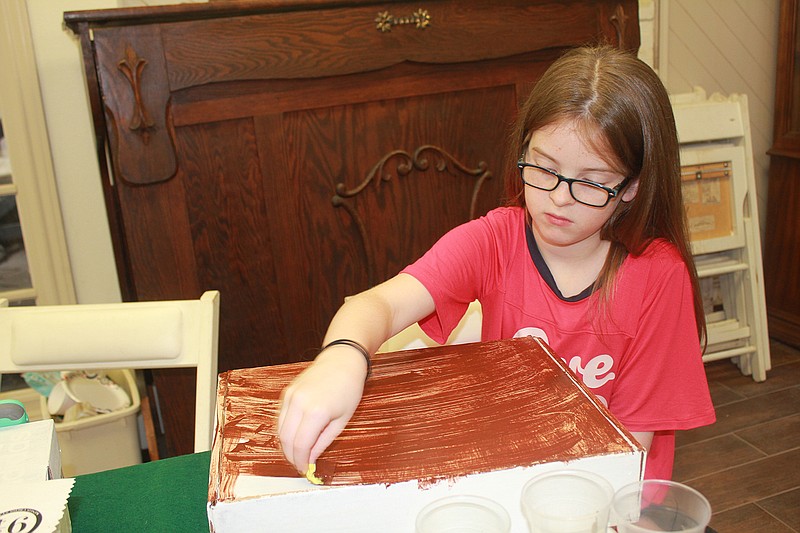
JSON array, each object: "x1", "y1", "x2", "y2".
[{"x1": 208, "y1": 337, "x2": 645, "y2": 533}]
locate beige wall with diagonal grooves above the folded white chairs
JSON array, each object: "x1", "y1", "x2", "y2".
[{"x1": 661, "y1": 0, "x2": 779, "y2": 242}]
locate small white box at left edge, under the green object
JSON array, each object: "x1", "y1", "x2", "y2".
[{"x1": 0, "y1": 420, "x2": 62, "y2": 486}]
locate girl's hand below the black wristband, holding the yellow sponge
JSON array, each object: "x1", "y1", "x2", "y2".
[{"x1": 278, "y1": 345, "x2": 367, "y2": 474}]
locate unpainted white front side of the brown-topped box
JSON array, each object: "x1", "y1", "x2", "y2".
[{"x1": 208, "y1": 450, "x2": 645, "y2": 533}]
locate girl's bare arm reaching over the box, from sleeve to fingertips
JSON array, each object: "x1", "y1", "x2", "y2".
[{"x1": 278, "y1": 274, "x2": 435, "y2": 473}]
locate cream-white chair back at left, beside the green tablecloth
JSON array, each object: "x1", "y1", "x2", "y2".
[{"x1": 0, "y1": 291, "x2": 219, "y2": 452}]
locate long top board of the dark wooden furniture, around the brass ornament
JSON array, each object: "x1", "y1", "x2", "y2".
[{"x1": 158, "y1": 0, "x2": 598, "y2": 91}]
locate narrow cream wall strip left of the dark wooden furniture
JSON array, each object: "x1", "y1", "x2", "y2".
[{"x1": 27, "y1": 0, "x2": 120, "y2": 303}]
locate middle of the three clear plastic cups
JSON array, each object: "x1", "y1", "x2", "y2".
[{"x1": 521, "y1": 470, "x2": 614, "y2": 533}]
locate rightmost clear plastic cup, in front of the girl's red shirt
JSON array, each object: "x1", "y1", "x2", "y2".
[{"x1": 612, "y1": 479, "x2": 711, "y2": 533}]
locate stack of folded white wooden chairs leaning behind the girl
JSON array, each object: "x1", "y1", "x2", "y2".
[{"x1": 672, "y1": 88, "x2": 770, "y2": 381}]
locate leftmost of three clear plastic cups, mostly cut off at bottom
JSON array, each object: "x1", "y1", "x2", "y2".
[{"x1": 416, "y1": 495, "x2": 511, "y2": 533}]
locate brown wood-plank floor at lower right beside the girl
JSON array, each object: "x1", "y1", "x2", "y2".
[{"x1": 673, "y1": 341, "x2": 800, "y2": 533}]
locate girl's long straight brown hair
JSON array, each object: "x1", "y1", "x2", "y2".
[{"x1": 506, "y1": 45, "x2": 706, "y2": 342}]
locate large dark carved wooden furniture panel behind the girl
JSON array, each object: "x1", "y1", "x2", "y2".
[{"x1": 64, "y1": 0, "x2": 639, "y2": 453}]
